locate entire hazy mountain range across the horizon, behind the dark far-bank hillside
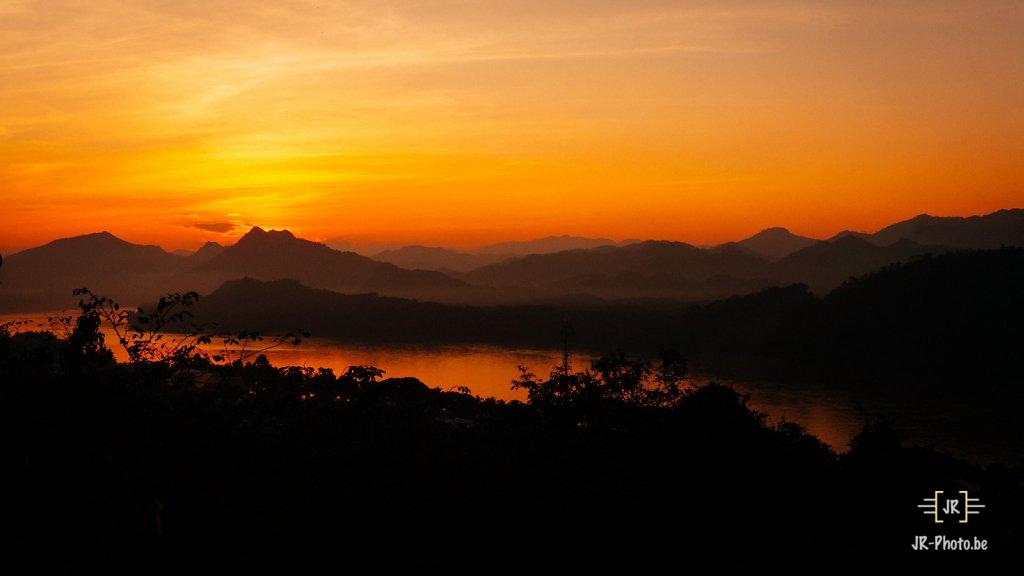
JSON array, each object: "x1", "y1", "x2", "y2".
[{"x1": 0, "y1": 209, "x2": 1024, "y2": 312}]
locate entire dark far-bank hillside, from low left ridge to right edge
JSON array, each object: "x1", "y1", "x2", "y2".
[{"x1": 188, "y1": 249, "x2": 1024, "y2": 385}]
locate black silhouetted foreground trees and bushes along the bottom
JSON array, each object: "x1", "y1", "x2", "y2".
[{"x1": 0, "y1": 307, "x2": 1024, "y2": 574}]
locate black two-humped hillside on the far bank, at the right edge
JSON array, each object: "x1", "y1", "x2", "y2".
[{"x1": 677, "y1": 248, "x2": 1024, "y2": 387}]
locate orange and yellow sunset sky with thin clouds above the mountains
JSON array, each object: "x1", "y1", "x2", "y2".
[{"x1": 0, "y1": 0, "x2": 1024, "y2": 251}]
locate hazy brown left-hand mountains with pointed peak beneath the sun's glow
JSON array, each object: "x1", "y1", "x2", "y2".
[{"x1": 0, "y1": 228, "x2": 465, "y2": 311}]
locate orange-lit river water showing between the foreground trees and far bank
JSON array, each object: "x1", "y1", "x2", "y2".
[{"x1": 0, "y1": 315, "x2": 1022, "y2": 461}]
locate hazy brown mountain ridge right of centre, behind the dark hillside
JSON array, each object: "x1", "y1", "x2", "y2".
[{"x1": 462, "y1": 236, "x2": 948, "y2": 299}]
